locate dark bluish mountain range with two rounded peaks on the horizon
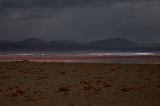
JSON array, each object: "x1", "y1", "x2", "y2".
[{"x1": 0, "y1": 38, "x2": 160, "y2": 52}]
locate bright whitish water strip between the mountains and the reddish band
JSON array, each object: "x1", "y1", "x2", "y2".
[{"x1": 0, "y1": 51, "x2": 160, "y2": 56}]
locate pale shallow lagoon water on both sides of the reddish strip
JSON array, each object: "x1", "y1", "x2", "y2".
[{"x1": 0, "y1": 51, "x2": 160, "y2": 64}]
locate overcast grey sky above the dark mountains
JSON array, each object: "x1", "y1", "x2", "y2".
[{"x1": 0, "y1": 0, "x2": 160, "y2": 43}]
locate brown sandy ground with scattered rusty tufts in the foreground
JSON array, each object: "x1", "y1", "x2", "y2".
[{"x1": 0, "y1": 61, "x2": 160, "y2": 106}]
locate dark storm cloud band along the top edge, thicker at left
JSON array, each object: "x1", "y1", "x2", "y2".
[{"x1": 0, "y1": 0, "x2": 158, "y2": 9}]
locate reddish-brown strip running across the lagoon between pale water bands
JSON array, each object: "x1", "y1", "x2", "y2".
[{"x1": 0, "y1": 55, "x2": 160, "y2": 60}]
